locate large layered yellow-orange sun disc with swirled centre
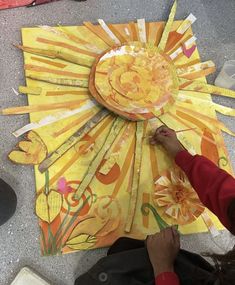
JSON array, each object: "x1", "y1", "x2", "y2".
[{"x1": 89, "y1": 42, "x2": 178, "y2": 120}]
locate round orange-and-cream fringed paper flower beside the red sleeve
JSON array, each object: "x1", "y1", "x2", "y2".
[{"x1": 153, "y1": 169, "x2": 205, "y2": 225}]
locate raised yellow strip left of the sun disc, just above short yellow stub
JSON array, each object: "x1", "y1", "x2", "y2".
[{"x1": 26, "y1": 74, "x2": 88, "y2": 87}]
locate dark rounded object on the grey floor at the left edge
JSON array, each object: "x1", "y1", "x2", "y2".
[{"x1": 0, "y1": 179, "x2": 17, "y2": 226}]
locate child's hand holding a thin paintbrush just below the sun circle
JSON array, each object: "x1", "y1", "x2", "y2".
[{"x1": 150, "y1": 126, "x2": 184, "y2": 157}]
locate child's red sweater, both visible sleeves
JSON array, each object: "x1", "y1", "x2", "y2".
[{"x1": 155, "y1": 150, "x2": 235, "y2": 285}]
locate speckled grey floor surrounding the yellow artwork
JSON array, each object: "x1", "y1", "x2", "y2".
[{"x1": 0, "y1": 0, "x2": 235, "y2": 285}]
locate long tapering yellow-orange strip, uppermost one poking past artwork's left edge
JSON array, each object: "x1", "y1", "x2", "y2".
[{"x1": 16, "y1": 45, "x2": 94, "y2": 67}]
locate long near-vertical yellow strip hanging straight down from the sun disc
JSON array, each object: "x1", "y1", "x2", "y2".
[{"x1": 125, "y1": 122, "x2": 144, "y2": 233}]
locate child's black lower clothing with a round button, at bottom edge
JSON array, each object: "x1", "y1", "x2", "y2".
[{"x1": 75, "y1": 238, "x2": 216, "y2": 285}]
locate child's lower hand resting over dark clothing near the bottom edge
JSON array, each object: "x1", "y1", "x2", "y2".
[{"x1": 147, "y1": 227, "x2": 180, "y2": 276}]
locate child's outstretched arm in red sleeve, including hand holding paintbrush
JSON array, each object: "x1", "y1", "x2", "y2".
[{"x1": 151, "y1": 126, "x2": 235, "y2": 233}]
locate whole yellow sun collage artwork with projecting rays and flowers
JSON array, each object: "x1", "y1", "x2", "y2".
[{"x1": 2, "y1": 2, "x2": 235, "y2": 255}]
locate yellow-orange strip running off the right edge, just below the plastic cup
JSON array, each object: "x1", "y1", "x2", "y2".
[{"x1": 179, "y1": 79, "x2": 235, "y2": 98}]
